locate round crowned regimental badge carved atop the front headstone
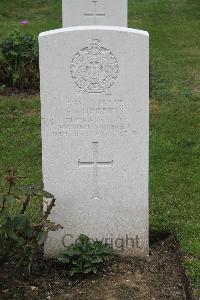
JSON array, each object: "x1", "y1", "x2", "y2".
[{"x1": 70, "y1": 40, "x2": 119, "y2": 93}]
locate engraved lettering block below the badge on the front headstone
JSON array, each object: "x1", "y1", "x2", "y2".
[{"x1": 48, "y1": 95, "x2": 136, "y2": 139}]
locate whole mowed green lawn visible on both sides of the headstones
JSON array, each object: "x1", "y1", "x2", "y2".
[{"x1": 0, "y1": 0, "x2": 200, "y2": 296}]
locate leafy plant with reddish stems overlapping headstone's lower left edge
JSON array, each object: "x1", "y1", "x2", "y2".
[{"x1": 0, "y1": 169, "x2": 62, "y2": 268}]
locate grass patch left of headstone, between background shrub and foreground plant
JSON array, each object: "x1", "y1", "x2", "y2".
[{"x1": 0, "y1": 96, "x2": 42, "y2": 186}]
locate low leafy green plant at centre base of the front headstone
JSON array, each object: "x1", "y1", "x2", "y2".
[{"x1": 58, "y1": 234, "x2": 114, "y2": 277}]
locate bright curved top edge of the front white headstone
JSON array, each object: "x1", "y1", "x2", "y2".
[{"x1": 39, "y1": 26, "x2": 149, "y2": 39}]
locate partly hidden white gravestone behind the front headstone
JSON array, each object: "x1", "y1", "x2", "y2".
[{"x1": 62, "y1": 0, "x2": 128, "y2": 27}]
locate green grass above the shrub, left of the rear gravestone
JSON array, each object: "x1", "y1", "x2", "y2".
[{"x1": 0, "y1": 0, "x2": 62, "y2": 37}]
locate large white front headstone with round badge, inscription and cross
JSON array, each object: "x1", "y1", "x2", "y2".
[{"x1": 39, "y1": 26, "x2": 149, "y2": 256}]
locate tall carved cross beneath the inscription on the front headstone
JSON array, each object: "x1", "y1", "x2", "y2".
[{"x1": 78, "y1": 142, "x2": 113, "y2": 200}]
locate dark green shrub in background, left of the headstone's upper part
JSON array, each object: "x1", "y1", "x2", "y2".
[{"x1": 0, "y1": 29, "x2": 39, "y2": 91}]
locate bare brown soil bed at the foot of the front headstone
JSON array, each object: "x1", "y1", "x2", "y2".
[{"x1": 0, "y1": 235, "x2": 192, "y2": 300}]
